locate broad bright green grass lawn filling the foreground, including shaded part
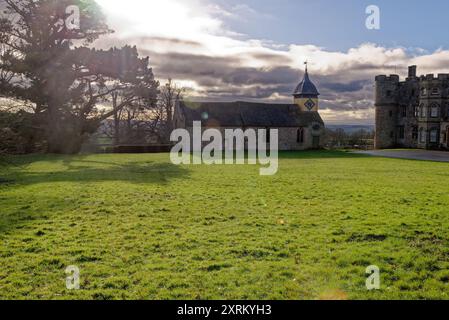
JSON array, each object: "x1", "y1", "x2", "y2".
[{"x1": 0, "y1": 152, "x2": 449, "y2": 300}]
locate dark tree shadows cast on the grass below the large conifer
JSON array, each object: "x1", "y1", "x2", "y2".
[{"x1": 0, "y1": 155, "x2": 190, "y2": 234}]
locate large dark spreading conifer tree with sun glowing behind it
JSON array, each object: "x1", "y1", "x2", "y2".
[{"x1": 0, "y1": 0, "x2": 158, "y2": 153}]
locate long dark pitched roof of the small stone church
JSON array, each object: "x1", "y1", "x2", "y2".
[{"x1": 179, "y1": 101, "x2": 324, "y2": 128}]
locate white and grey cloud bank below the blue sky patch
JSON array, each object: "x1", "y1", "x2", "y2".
[{"x1": 96, "y1": 0, "x2": 449, "y2": 123}]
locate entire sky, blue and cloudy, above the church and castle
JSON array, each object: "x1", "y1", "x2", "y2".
[{"x1": 95, "y1": 0, "x2": 449, "y2": 124}]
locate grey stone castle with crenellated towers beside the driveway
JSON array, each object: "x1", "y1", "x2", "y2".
[{"x1": 375, "y1": 66, "x2": 449, "y2": 149}]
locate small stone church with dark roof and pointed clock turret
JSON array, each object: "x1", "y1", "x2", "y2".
[{"x1": 174, "y1": 68, "x2": 325, "y2": 151}]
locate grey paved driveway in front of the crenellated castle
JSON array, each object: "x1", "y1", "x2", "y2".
[{"x1": 355, "y1": 149, "x2": 449, "y2": 162}]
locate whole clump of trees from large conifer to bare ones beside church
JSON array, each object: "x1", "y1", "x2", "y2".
[{"x1": 0, "y1": 0, "x2": 182, "y2": 154}]
